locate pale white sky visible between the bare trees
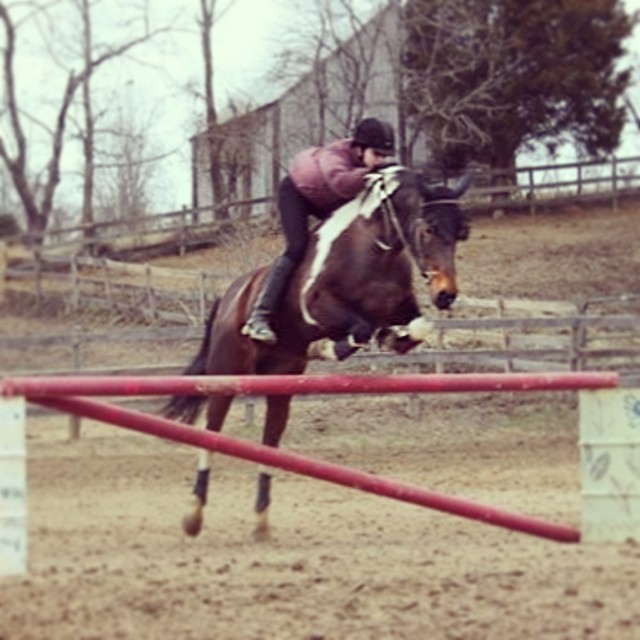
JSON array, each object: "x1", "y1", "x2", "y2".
[{"x1": 1, "y1": 0, "x2": 640, "y2": 211}]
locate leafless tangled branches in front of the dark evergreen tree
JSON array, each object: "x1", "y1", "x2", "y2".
[{"x1": 401, "y1": 0, "x2": 520, "y2": 169}]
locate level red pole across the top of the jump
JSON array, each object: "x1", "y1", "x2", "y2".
[{"x1": 0, "y1": 371, "x2": 619, "y2": 397}]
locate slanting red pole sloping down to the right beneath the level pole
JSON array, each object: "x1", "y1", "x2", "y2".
[{"x1": 30, "y1": 396, "x2": 580, "y2": 542}]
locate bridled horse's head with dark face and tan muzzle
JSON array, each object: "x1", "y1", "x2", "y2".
[{"x1": 384, "y1": 170, "x2": 471, "y2": 309}]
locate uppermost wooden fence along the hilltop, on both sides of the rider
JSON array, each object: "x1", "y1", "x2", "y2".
[{"x1": 5, "y1": 156, "x2": 640, "y2": 255}]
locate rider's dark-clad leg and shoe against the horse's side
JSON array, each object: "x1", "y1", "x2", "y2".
[{"x1": 242, "y1": 177, "x2": 309, "y2": 344}]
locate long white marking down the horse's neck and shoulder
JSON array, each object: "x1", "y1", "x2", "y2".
[{"x1": 300, "y1": 166, "x2": 402, "y2": 325}]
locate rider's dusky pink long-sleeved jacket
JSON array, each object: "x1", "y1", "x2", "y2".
[{"x1": 289, "y1": 138, "x2": 369, "y2": 214}]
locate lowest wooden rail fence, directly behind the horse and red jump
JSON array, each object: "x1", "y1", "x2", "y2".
[{"x1": 5, "y1": 296, "x2": 640, "y2": 375}]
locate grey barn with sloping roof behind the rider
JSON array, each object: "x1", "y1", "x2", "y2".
[{"x1": 191, "y1": 0, "x2": 416, "y2": 217}]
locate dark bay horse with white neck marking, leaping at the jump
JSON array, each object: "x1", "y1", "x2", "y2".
[{"x1": 163, "y1": 166, "x2": 470, "y2": 539}]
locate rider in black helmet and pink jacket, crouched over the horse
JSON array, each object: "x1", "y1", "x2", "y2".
[{"x1": 242, "y1": 118, "x2": 395, "y2": 344}]
